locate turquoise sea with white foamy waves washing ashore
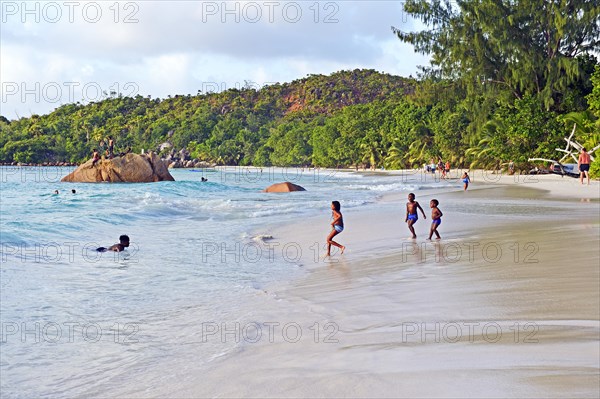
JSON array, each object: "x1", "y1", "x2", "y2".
[{"x1": 0, "y1": 167, "x2": 464, "y2": 397}]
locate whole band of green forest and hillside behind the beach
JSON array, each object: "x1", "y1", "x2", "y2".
[{"x1": 0, "y1": 64, "x2": 600, "y2": 168}]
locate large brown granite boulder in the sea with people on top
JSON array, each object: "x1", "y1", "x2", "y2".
[{"x1": 61, "y1": 152, "x2": 175, "y2": 183}]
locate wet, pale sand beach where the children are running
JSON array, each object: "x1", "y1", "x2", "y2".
[{"x1": 157, "y1": 171, "x2": 600, "y2": 398}]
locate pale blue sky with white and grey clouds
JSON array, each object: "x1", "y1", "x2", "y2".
[{"x1": 0, "y1": 0, "x2": 428, "y2": 119}]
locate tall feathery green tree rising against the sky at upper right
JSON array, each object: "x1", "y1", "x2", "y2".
[{"x1": 393, "y1": 0, "x2": 600, "y2": 109}]
